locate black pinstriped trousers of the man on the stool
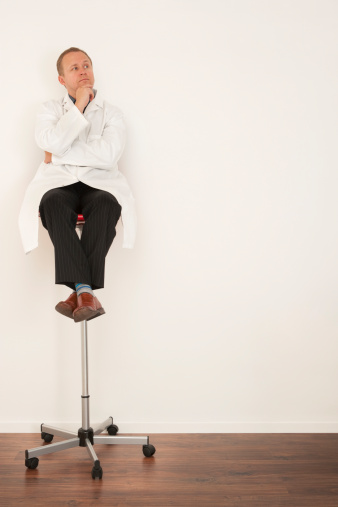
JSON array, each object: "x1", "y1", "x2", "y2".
[{"x1": 40, "y1": 182, "x2": 121, "y2": 289}]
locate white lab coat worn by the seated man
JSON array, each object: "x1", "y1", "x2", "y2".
[{"x1": 19, "y1": 93, "x2": 136, "y2": 253}]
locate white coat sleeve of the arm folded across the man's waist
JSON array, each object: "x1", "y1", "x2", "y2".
[{"x1": 52, "y1": 108, "x2": 126, "y2": 170}]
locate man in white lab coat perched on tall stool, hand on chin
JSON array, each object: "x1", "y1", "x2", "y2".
[{"x1": 19, "y1": 47, "x2": 136, "y2": 322}]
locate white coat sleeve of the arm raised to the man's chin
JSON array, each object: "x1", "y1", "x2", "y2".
[{"x1": 35, "y1": 101, "x2": 88, "y2": 156}]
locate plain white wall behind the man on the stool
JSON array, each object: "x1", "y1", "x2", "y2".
[{"x1": 0, "y1": 0, "x2": 338, "y2": 432}]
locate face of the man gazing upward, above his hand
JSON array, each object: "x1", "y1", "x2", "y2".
[{"x1": 59, "y1": 51, "x2": 94, "y2": 98}]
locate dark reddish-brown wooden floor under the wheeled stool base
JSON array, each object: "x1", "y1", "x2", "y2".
[{"x1": 0, "y1": 434, "x2": 338, "y2": 507}]
